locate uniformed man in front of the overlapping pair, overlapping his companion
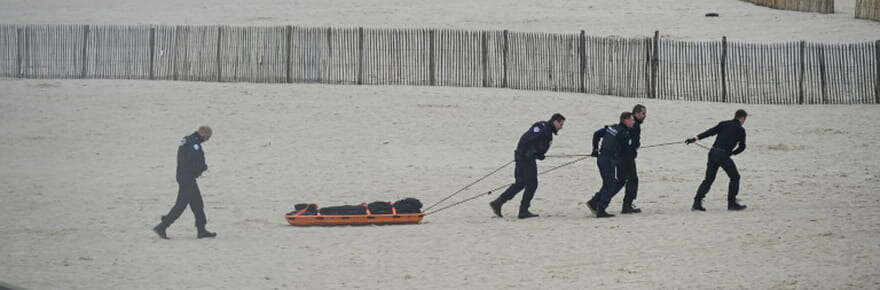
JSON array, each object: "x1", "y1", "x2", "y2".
[{"x1": 587, "y1": 112, "x2": 635, "y2": 218}]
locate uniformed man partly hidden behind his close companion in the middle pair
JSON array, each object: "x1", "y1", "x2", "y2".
[{"x1": 620, "y1": 104, "x2": 648, "y2": 214}]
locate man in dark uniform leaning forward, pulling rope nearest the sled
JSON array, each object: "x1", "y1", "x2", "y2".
[{"x1": 489, "y1": 113, "x2": 565, "y2": 219}]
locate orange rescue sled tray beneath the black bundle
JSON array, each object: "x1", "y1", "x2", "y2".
[{"x1": 285, "y1": 209, "x2": 425, "y2": 227}]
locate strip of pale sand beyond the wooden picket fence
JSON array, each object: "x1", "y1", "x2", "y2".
[{"x1": 0, "y1": 0, "x2": 880, "y2": 42}]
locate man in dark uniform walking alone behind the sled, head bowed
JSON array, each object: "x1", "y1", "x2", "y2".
[{"x1": 153, "y1": 126, "x2": 217, "y2": 239}]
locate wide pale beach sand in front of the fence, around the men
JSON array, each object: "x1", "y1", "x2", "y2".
[{"x1": 0, "y1": 80, "x2": 880, "y2": 289}]
